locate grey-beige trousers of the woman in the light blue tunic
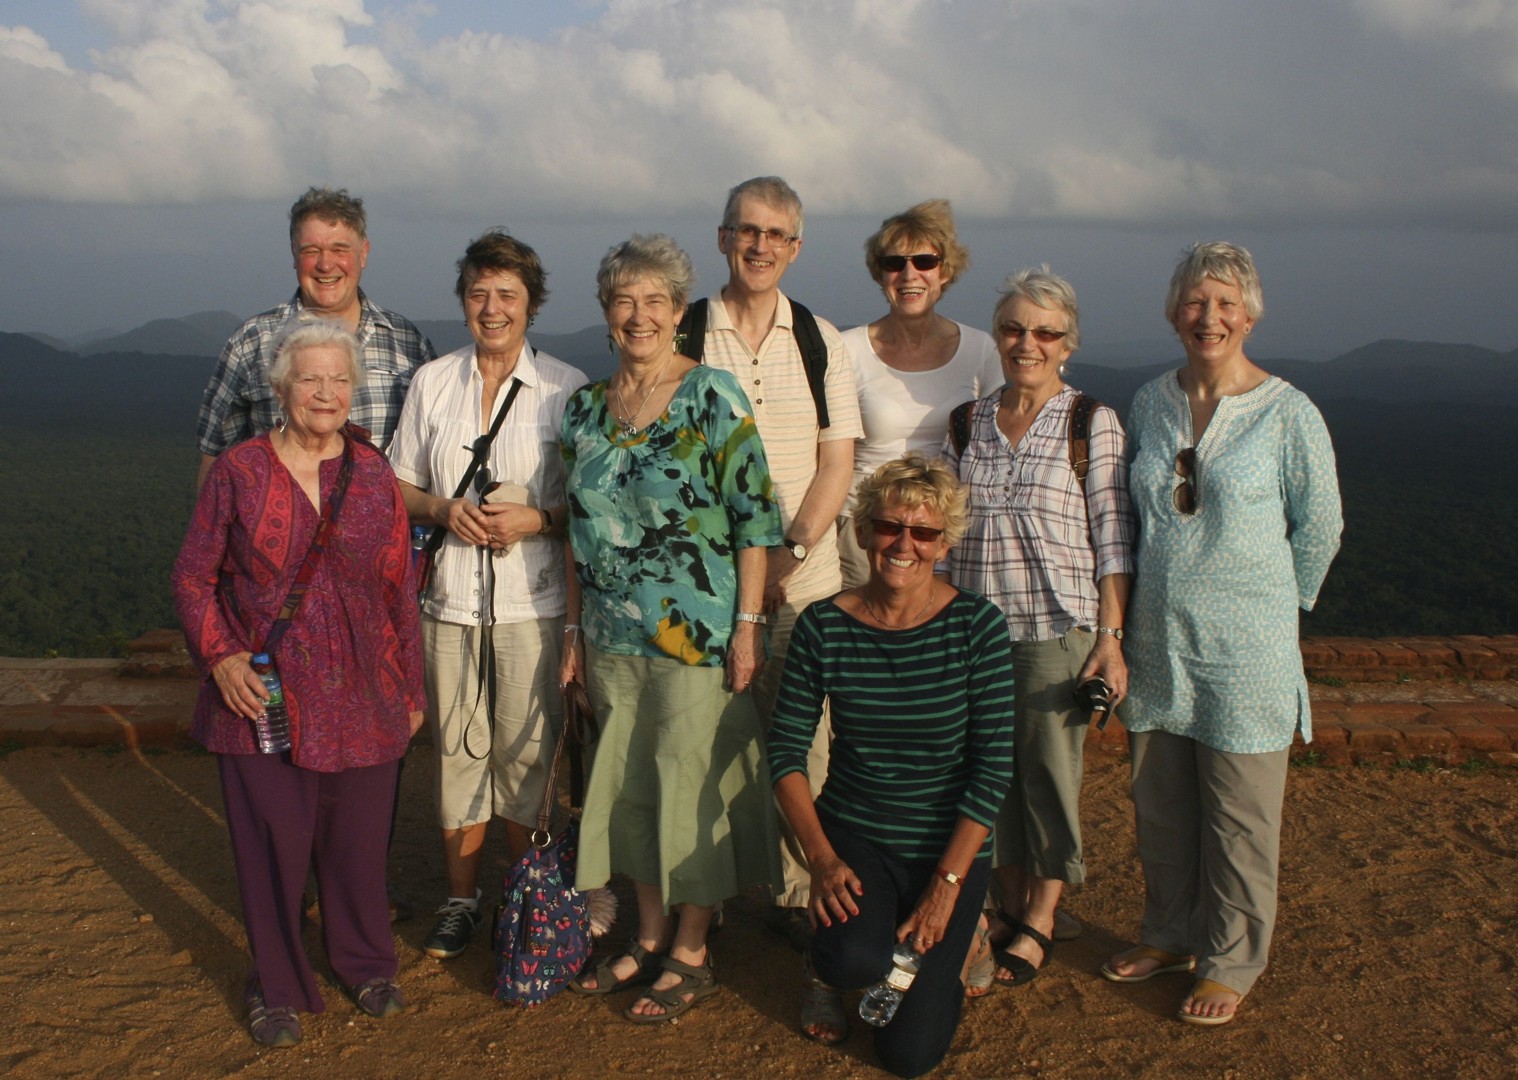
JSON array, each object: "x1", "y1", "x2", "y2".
[{"x1": 1128, "y1": 731, "x2": 1287, "y2": 995}]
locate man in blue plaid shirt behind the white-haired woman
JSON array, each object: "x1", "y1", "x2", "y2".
[{"x1": 196, "y1": 187, "x2": 436, "y2": 488}]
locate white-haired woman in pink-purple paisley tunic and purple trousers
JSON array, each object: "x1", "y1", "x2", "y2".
[{"x1": 173, "y1": 322, "x2": 424, "y2": 1047}]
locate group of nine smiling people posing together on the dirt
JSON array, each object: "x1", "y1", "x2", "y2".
[{"x1": 175, "y1": 176, "x2": 1340, "y2": 1075}]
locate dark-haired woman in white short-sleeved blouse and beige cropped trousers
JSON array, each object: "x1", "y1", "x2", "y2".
[{"x1": 390, "y1": 229, "x2": 586, "y2": 960}]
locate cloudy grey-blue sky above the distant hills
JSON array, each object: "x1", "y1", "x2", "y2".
[{"x1": 0, "y1": 0, "x2": 1518, "y2": 357}]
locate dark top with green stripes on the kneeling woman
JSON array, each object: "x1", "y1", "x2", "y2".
[{"x1": 768, "y1": 591, "x2": 1013, "y2": 860}]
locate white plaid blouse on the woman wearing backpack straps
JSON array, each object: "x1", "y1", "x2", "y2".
[{"x1": 943, "y1": 386, "x2": 1137, "y2": 641}]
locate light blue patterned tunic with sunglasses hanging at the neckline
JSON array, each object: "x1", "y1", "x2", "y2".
[{"x1": 1123, "y1": 372, "x2": 1343, "y2": 753}]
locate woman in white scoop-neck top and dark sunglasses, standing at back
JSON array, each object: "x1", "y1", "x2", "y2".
[{"x1": 838, "y1": 199, "x2": 1002, "y2": 588}]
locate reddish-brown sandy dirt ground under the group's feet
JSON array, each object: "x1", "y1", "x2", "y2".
[{"x1": 0, "y1": 749, "x2": 1518, "y2": 1080}]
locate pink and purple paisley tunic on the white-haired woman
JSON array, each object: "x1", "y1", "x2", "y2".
[{"x1": 173, "y1": 434, "x2": 425, "y2": 773}]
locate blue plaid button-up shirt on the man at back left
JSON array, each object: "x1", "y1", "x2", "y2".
[{"x1": 196, "y1": 290, "x2": 437, "y2": 457}]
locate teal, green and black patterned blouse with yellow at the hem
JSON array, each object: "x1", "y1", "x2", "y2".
[{"x1": 560, "y1": 366, "x2": 782, "y2": 667}]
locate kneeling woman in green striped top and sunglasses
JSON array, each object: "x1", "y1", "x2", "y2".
[{"x1": 770, "y1": 454, "x2": 1013, "y2": 1077}]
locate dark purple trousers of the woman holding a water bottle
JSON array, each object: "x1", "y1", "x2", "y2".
[{"x1": 217, "y1": 753, "x2": 399, "y2": 1013}]
